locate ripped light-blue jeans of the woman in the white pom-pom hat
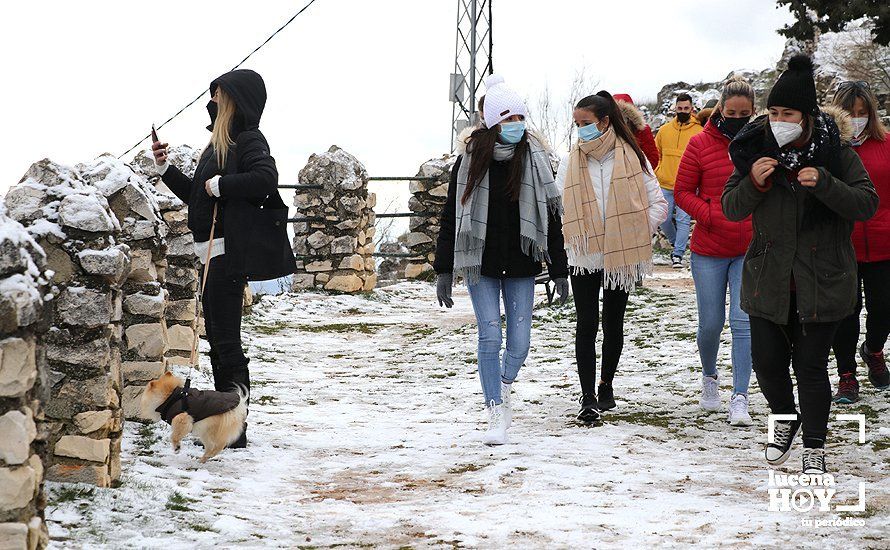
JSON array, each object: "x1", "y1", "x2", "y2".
[{"x1": 467, "y1": 277, "x2": 535, "y2": 405}]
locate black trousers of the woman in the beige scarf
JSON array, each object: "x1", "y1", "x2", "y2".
[{"x1": 572, "y1": 271, "x2": 630, "y2": 394}]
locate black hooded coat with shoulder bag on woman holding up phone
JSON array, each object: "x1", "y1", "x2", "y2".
[{"x1": 161, "y1": 70, "x2": 296, "y2": 281}]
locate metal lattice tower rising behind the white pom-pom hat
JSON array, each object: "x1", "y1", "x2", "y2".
[{"x1": 450, "y1": 0, "x2": 494, "y2": 151}]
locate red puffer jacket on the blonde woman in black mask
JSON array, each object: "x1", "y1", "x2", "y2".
[{"x1": 674, "y1": 121, "x2": 753, "y2": 258}]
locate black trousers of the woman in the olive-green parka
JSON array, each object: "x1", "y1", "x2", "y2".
[{"x1": 751, "y1": 294, "x2": 839, "y2": 447}]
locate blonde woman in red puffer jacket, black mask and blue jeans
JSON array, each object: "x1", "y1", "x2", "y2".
[{"x1": 674, "y1": 77, "x2": 754, "y2": 426}]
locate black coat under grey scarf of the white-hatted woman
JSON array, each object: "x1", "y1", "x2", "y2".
[{"x1": 433, "y1": 156, "x2": 569, "y2": 280}]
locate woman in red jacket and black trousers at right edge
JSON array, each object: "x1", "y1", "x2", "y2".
[{"x1": 833, "y1": 82, "x2": 890, "y2": 403}]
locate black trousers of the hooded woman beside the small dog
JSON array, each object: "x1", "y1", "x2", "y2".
[{"x1": 199, "y1": 254, "x2": 250, "y2": 391}]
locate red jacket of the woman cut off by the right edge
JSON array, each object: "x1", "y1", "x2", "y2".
[{"x1": 853, "y1": 136, "x2": 890, "y2": 262}]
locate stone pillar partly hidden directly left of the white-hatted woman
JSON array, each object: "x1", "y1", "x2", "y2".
[{"x1": 405, "y1": 155, "x2": 457, "y2": 280}]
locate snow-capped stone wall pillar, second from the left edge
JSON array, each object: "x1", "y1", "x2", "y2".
[{"x1": 5, "y1": 160, "x2": 130, "y2": 487}]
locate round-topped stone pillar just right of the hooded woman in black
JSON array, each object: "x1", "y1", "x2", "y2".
[{"x1": 293, "y1": 145, "x2": 377, "y2": 293}]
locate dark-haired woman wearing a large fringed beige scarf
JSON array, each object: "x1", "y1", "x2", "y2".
[{"x1": 556, "y1": 91, "x2": 667, "y2": 422}]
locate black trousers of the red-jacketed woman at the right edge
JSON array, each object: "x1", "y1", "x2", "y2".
[{"x1": 833, "y1": 260, "x2": 890, "y2": 374}]
